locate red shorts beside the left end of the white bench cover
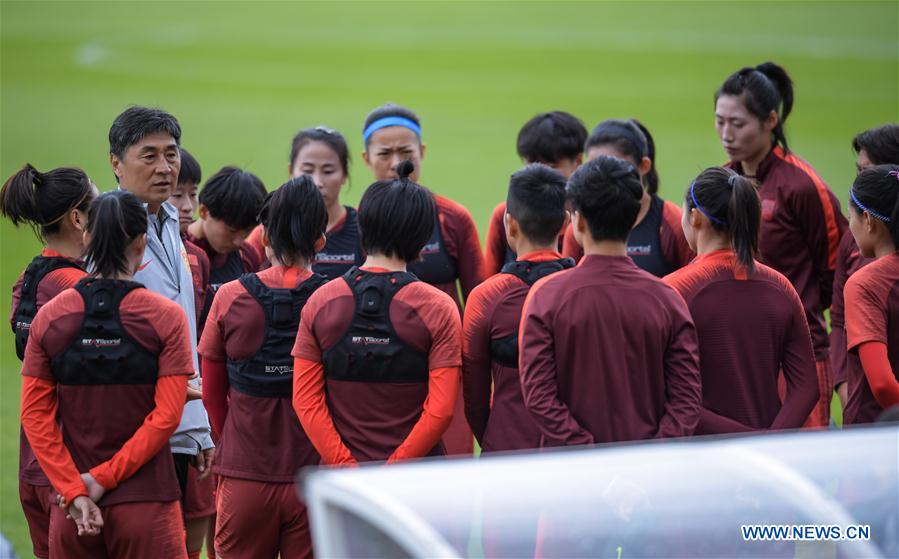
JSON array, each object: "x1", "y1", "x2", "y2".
[{"x1": 215, "y1": 477, "x2": 312, "y2": 559}]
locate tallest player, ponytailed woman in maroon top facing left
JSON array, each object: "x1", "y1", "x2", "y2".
[{"x1": 715, "y1": 62, "x2": 846, "y2": 427}]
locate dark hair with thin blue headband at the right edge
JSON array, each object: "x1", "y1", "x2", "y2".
[{"x1": 849, "y1": 165, "x2": 899, "y2": 249}]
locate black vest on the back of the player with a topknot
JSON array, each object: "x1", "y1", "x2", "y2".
[{"x1": 322, "y1": 267, "x2": 429, "y2": 383}]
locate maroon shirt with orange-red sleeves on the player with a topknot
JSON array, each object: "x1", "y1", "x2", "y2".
[{"x1": 293, "y1": 269, "x2": 461, "y2": 464}]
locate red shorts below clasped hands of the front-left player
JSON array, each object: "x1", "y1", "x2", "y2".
[{"x1": 50, "y1": 501, "x2": 187, "y2": 559}]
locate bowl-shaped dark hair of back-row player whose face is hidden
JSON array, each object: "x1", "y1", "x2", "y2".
[{"x1": 517, "y1": 111, "x2": 587, "y2": 164}]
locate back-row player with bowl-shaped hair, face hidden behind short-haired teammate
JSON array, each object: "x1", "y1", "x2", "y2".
[{"x1": 484, "y1": 111, "x2": 587, "y2": 277}]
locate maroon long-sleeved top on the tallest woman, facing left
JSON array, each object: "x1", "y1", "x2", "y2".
[{"x1": 728, "y1": 146, "x2": 847, "y2": 361}]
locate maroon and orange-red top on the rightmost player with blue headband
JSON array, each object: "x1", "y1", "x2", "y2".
[{"x1": 843, "y1": 253, "x2": 899, "y2": 425}]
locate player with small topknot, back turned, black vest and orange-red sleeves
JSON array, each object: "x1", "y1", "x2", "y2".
[{"x1": 293, "y1": 161, "x2": 462, "y2": 465}]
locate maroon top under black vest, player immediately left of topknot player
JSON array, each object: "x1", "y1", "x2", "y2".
[{"x1": 197, "y1": 266, "x2": 320, "y2": 483}]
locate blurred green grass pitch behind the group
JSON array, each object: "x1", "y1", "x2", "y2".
[{"x1": 0, "y1": 1, "x2": 899, "y2": 556}]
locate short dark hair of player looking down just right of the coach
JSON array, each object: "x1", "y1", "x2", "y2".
[{"x1": 200, "y1": 167, "x2": 266, "y2": 230}]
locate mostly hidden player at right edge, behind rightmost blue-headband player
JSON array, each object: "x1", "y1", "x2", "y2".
[{"x1": 830, "y1": 124, "x2": 899, "y2": 408}]
